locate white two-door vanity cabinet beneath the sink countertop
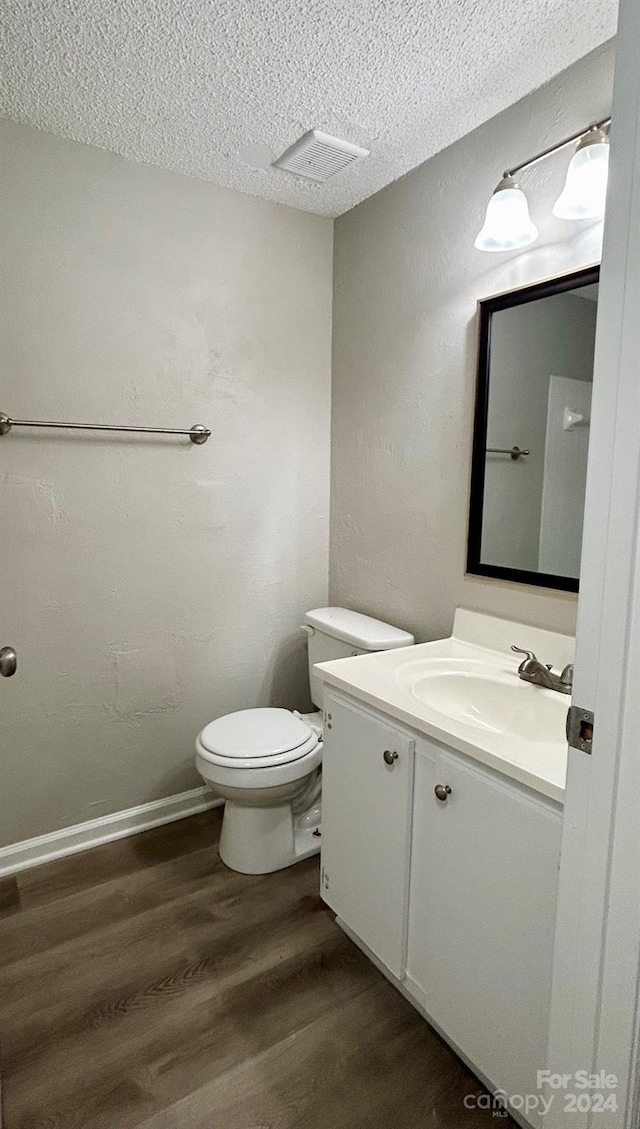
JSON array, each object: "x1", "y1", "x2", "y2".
[{"x1": 322, "y1": 688, "x2": 562, "y2": 1123}]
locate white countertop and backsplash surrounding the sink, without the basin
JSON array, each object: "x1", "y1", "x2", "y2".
[{"x1": 315, "y1": 609, "x2": 573, "y2": 803}]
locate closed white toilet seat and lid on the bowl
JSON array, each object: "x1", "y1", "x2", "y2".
[{"x1": 198, "y1": 708, "x2": 319, "y2": 770}]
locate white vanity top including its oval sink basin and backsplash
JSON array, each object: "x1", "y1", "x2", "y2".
[{"x1": 315, "y1": 609, "x2": 573, "y2": 803}]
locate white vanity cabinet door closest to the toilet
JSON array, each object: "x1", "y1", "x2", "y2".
[{"x1": 322, "y1": 694, "x2": 413, "y2": 977}]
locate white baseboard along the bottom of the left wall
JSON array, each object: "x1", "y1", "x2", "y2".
[{"x1": 0, "y1": 786, "x2": 223, "y2": 877}]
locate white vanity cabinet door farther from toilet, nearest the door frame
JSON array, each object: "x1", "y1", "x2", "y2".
[{"x1": 407, "y1": 753, "x2": 561, "y2": 1124}]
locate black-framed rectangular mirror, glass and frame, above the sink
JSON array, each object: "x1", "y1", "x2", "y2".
[{"x1": 467, "y1": 266, "x2": 599, "y2": 592}]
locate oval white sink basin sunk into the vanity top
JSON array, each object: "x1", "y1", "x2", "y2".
[{"x1": 394, "y1": 658, "x2": 570, "y2": 744}]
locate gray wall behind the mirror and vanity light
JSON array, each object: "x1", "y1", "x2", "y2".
[{"x1": 330, "y1": 44, "x2": 613, "y2": 641}]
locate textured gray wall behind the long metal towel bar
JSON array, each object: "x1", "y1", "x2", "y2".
[{"x1": 0, "y1": 124, "x2": 332, "y2": 843}]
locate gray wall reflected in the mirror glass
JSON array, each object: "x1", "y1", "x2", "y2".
[{"x1": 481, "y1": 294, "x2": 597, "y2": 571}]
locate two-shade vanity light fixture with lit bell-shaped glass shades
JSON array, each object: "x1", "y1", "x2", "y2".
[{"x1": 474, "y1": 117, "x2": 611, "y2": 252}]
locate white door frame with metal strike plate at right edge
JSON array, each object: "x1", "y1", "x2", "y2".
[{"x1": 545, "y1": 0, "x2": 640, "y2": 1129}]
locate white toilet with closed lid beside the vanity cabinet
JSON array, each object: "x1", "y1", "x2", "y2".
[{"x1": 195, "y1": 607, "x2": 414, "y2": 874}]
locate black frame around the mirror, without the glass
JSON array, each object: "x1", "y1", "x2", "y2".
[{"x1": 466, "y1": 265, "x2": 600, "y2": 592}]
